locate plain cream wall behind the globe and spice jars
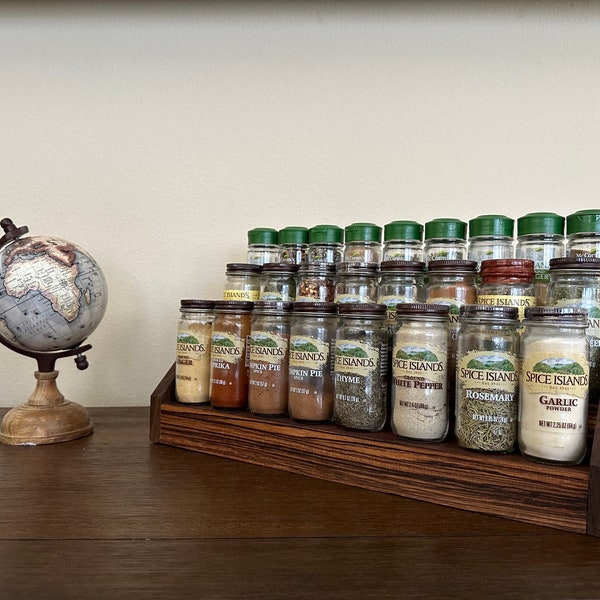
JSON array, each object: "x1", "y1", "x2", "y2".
[{"x1": 0, "y1": 1, "x2": 600, "y2": 406}]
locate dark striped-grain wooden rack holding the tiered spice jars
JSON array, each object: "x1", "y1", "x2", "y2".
[{"x1": 150, "y1": 365, "x2": 600, "y2": 537}]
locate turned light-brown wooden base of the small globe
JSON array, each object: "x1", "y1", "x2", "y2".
[{"x1": 0, "y1": 371, "x2": 93, "y2": 446}]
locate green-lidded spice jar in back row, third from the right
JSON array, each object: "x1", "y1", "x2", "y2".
[{"x1": 468, "y1": 215, "x2": 515, "y2": 265}]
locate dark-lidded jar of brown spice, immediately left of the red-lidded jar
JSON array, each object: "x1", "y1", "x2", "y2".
[{"x1": 427, "y1": 260, "x2": 477, "y2": 404}]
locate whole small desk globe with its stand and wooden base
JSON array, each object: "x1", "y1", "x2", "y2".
[{"x1": 0, "y1": 219, "x2": 108, "y2": 445}]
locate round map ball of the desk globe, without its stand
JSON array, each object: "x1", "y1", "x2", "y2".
[{"x1": 0, "y1": 236, "x2": 108, "y2": 352}]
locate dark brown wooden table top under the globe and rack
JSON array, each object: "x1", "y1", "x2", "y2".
[{"x1": 0, "y1": 408, "x2": 600, "y2": 600}]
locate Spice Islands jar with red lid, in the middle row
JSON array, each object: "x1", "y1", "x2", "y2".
[{"x1": 477, "y1": 258, "x2": 535, "y2": 321}]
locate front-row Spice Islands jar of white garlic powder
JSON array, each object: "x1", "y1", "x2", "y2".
[{"x1": 519, "y1": 307, "x2": 590, "y2": 465}]
